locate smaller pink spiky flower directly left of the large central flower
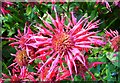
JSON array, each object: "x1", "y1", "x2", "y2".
[{"x1": 8, "y1": 23, "x2": 36, "y2": 59}]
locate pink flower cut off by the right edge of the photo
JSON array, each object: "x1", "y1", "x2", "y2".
[{"x1": 106, "y1": 30, "x2": 120, "y2": 51}]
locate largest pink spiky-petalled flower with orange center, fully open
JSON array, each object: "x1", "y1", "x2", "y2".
[{"x1": 29, "y1": 9, "x2": 101, "y2": 80}]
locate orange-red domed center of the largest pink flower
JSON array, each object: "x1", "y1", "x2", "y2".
[{"x1": 52, "y1": 33, "x2": 73, "y2": 52}]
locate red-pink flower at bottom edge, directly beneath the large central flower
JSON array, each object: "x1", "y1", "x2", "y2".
[{"x1": 37, "y1": 63, "x2": 70, "y2": 81}]
